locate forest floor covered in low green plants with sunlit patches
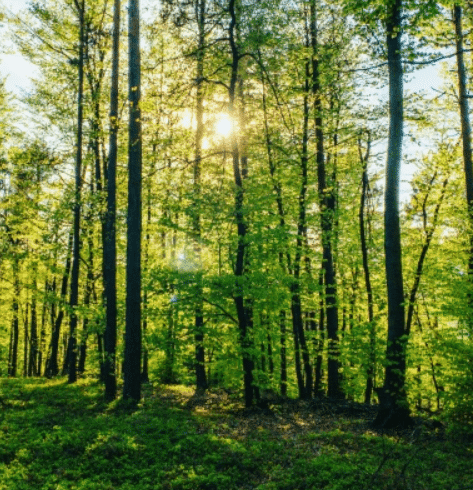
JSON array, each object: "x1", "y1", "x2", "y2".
[{"x1": 0, "y1": 379, "x2": 473, "y2": 490}]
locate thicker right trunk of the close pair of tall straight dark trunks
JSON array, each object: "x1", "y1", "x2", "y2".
[{"x1": 123, "y1": 0, "x2": 142, "y2": 402}]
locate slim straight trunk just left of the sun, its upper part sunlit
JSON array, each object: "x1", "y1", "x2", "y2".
[{"x1": 192, "y1": 0, "x2": 207, "y2": 390}]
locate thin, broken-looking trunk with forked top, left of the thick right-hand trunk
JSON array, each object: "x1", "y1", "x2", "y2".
[{"x1": 358, "y1": 132, "x2": 376, "y2": 404}]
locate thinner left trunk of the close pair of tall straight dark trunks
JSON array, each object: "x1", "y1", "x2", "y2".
[{"x1": 103, "y1": 0, "x2": 121, "y2": 401}]
